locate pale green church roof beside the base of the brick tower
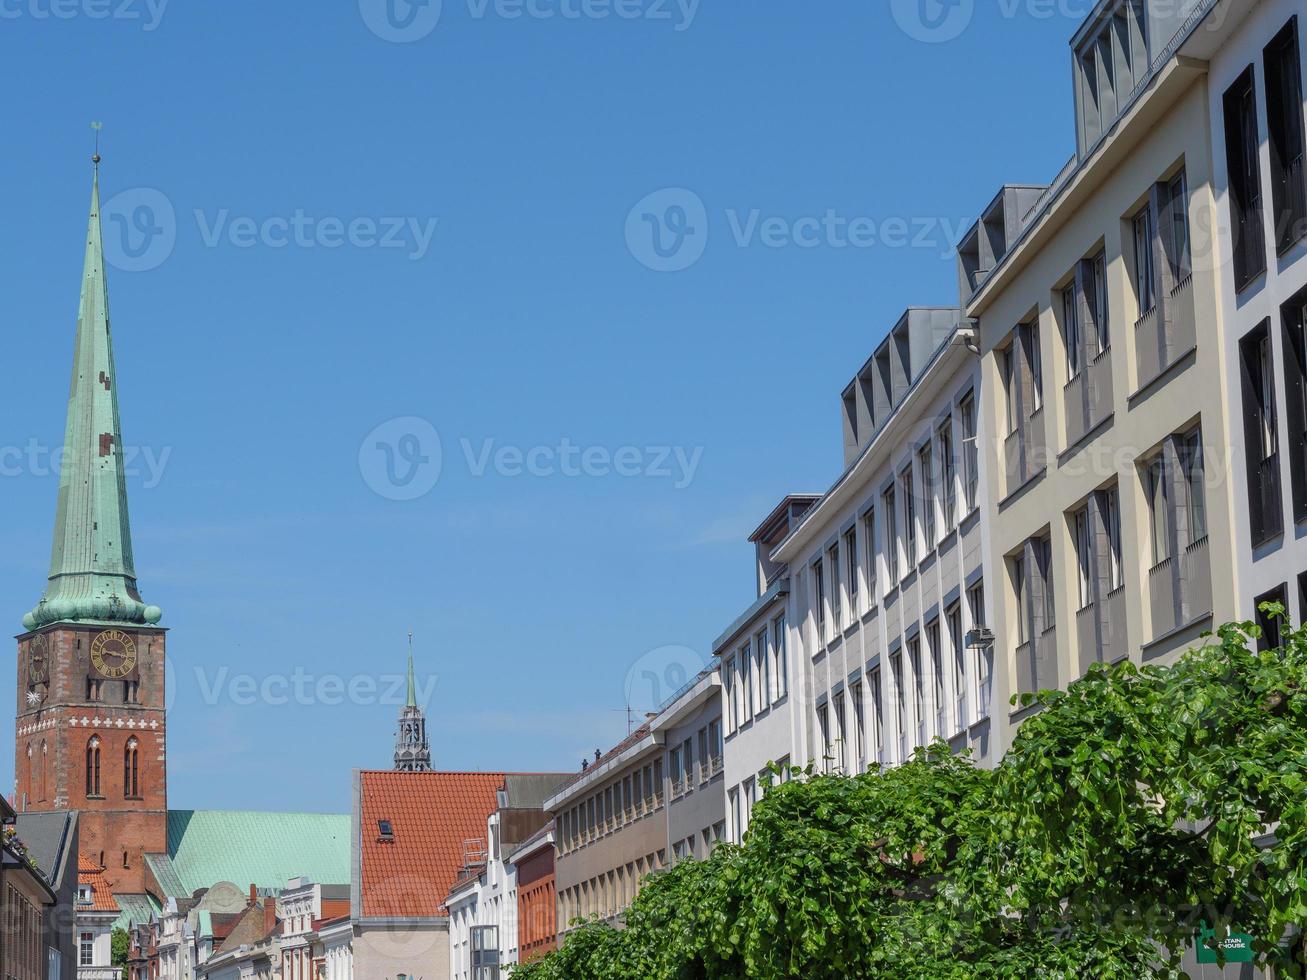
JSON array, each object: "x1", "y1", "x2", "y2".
[{"x1": 159, "y1": 810, "x2": 350, "y2": 896}]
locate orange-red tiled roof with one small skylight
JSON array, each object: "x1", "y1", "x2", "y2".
[{"x1": 358, "y1": 772, "x2": 505, "y2": 919}]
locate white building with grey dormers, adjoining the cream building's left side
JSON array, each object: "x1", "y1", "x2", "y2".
[{"x1": 771, "y1": 310, "x2": 993, "y2": 774}]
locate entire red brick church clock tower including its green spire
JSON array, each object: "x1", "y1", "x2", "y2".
[{"x1": 14, "y1": 163, "x2": 167, "y2": 894}]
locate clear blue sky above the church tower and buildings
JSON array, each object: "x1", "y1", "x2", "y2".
[{"x1": 0, "y1": 0, "x2": 1082, "y2": 811}]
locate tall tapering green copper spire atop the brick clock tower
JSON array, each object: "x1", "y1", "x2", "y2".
[{"x1": 22, "y1": 163, "x2": 163, "y2": 630}]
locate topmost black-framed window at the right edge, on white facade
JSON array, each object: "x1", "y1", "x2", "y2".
[{"x1": 1265, "y1": 17, "x2": 1307, "y2": 255}]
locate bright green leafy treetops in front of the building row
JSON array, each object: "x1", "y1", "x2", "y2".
[{"x1": 514, "y1": 606, "x2": 1307, "y2": 980}]
